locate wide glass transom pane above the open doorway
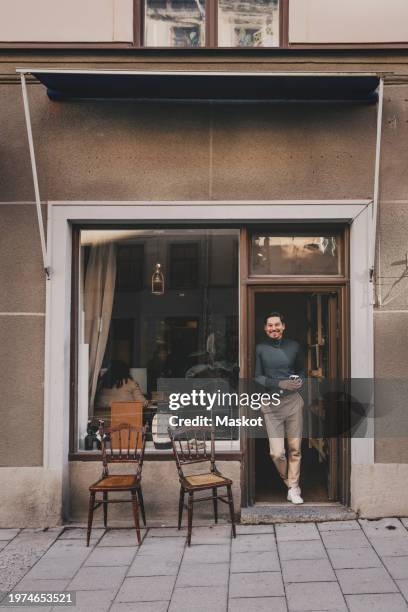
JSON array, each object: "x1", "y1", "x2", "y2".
[{"x1": 251, "y1": 234, "x2": 340, "y2": 276}]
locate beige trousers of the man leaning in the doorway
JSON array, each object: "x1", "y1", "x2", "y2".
[{"x1": 262, "y1": 393, "x2": 304, "y2": 488}]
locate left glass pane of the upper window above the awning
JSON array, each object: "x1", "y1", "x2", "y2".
[{"x1": 145, "y1": 0, "x2": 205, "y2": 47}]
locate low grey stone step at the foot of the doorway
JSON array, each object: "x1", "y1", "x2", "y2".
[{"x1": 241, "y1": 503, "x2": 357, "y2": 525}]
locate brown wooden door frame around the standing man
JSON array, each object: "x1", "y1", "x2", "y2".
[{"x1": 240, "y1": 224, "x2": 351, "y2": 507}]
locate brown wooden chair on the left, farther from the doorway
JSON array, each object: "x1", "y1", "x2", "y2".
[{"x1": 86, "y1": 421, "x2": 146, "y2": 546}]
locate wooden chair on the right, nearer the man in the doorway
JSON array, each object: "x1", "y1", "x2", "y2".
[{"x1": 168, "y1": 427, "x2": 236, "y2": 546}]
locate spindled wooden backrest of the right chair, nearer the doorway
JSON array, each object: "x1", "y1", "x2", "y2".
[{"x1": 168, "y1": 427, "x2": 216, "y2": 478}]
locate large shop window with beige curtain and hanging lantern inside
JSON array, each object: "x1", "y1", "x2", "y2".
[{"x1": 76, "y1": 229, "x2": 239, "y2": 451}]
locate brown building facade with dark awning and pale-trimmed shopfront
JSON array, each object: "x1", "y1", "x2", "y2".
[{"x1": 0, "y1": 0, "x2": 408, "y2": 527}]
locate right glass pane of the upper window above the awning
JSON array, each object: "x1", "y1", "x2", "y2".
[{"x1": 218, "y1": 0, "x2": 279, "y2": 47}]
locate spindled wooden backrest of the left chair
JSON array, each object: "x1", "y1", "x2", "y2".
[{"x1": 98, "y1": 421, "x2": 147, "y2": 476}]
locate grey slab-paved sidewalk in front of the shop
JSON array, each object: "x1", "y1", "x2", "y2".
[{"x1": 0, "y1": 518, "x2": 408, "y2": 612}]
